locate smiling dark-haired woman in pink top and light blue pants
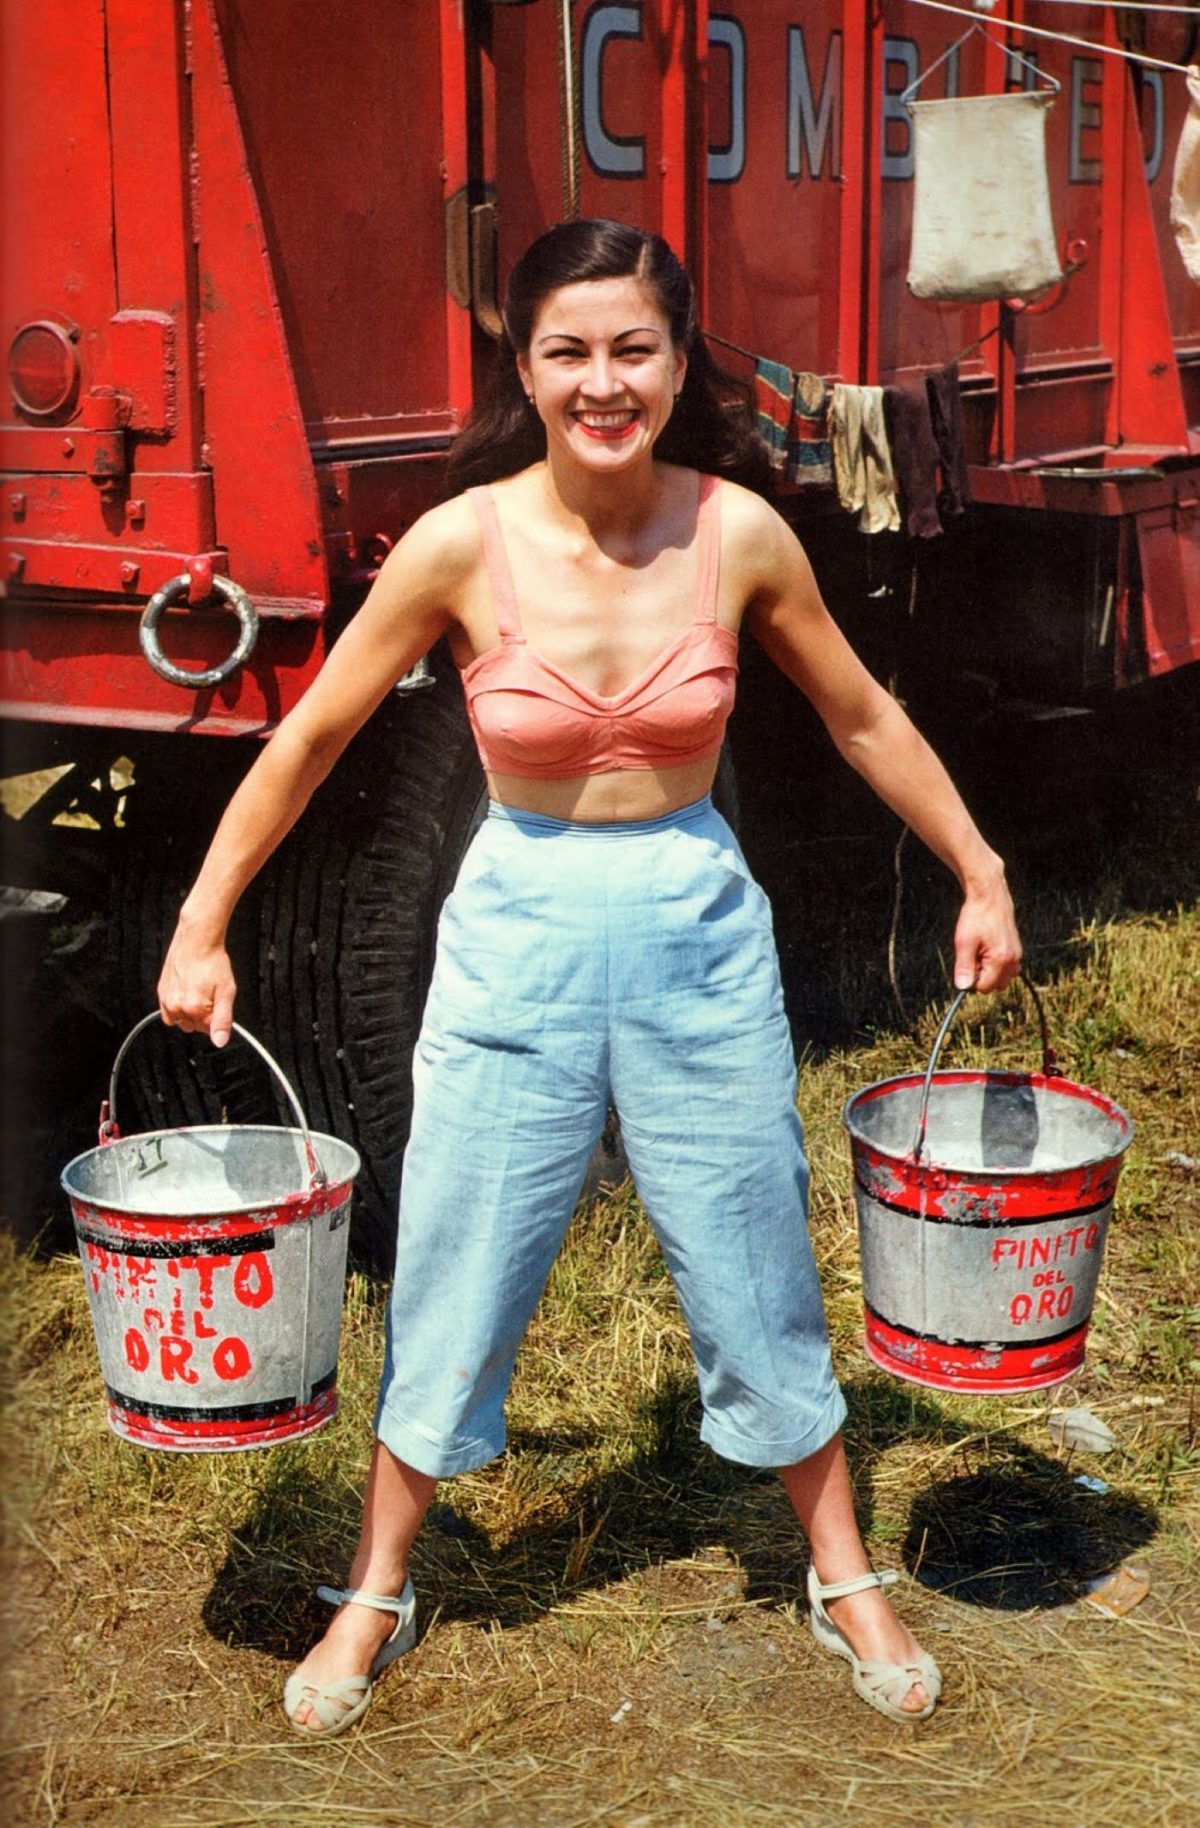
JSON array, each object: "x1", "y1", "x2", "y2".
[{"x1": 159, "y1": 221, "x2": 1021, "y2": 1737}]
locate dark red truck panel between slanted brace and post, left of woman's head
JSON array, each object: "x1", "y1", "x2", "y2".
[{"x1": 216, "y1": 0, "x2": 463, "y2": 442}]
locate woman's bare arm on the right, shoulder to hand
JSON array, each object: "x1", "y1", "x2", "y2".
[{"x1": 730, "y1": 495, "x2": 1021, "y2": 991}]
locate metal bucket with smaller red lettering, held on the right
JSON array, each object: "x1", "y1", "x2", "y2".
[{"x1": 843, "y1": 980, "x2": 1134, "y2": 1393}]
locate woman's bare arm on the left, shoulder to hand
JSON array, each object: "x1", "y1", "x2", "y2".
[{"x1": 159, "y1": 503, "x2": 477, "y2": 1047}]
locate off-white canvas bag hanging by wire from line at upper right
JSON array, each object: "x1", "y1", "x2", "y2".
[{"x1": 902, "y1": 26, "x2": 1063, "y2": 300}]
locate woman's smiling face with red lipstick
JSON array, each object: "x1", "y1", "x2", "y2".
[{"x1": 518, "y1": 278, "x2": 688, "y2": 472}]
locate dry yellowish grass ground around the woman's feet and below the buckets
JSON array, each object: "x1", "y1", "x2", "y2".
[{"x1": 2, "y1": 881, "x2": 1200, "y2": 1828}]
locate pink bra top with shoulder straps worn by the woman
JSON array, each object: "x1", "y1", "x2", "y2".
[{"x1": 463, "y1": 475, "x2": 737, "y2": 781}]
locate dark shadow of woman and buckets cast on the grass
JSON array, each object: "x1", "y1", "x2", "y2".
[{"x1": 203, "y1": 1378, "x2": 1158, "y2": 1660}]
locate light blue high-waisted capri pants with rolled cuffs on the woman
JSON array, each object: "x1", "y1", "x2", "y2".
[{"x1": 375, "y1": 799, "x2": 845, "y2": 1477}]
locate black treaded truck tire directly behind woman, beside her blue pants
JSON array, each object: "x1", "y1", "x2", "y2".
[{"x1": 260, "y1": 660, "x2": 485, "y2": 1272}]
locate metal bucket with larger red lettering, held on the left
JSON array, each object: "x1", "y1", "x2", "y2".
[{"x1": 62, "y1": 1015, "x2": 359, "y2": 1453}]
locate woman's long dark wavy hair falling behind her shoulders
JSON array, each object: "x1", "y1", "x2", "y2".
[{"x1": 446, "y1": 218, "x2": 770, "y2": 495}]
